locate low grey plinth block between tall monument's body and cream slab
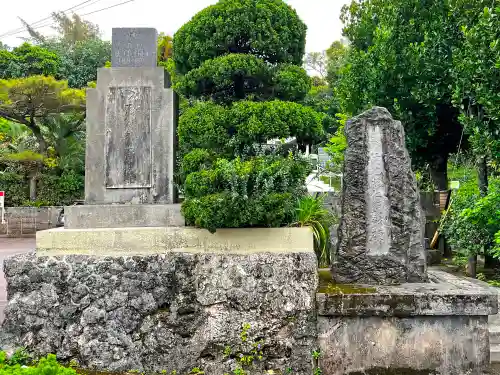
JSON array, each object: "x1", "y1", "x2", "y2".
[{"x1": 64, "y1": 204, "x2": 185, "y2": 229}]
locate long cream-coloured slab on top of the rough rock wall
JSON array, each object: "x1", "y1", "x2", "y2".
[{"x1": 36, "y1": 227, "x2": 314, "y2": 256}]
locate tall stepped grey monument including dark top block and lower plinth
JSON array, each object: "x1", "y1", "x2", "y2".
[{"x1": 66, "y1": 28, "x2": 180, "y2": 229}]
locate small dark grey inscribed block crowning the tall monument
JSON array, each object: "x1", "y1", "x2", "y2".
[{"x1": 111, "y1": 28, "x2": 158, "y2": 68}]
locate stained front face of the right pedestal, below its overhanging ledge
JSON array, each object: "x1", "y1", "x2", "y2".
[{"x1": 318, "y1": 316, "x2": 489, "y2": 375}]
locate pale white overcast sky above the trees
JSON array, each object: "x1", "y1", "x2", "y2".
[{"x1": 0, "y1": 0, "x2": 347, "y2": 52}]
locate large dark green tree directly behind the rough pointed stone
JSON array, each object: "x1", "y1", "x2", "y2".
[{"x1": 338, "y1": 0, "x2": 462, "y2": 190}]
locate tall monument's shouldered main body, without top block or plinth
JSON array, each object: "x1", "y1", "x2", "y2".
[{"x1": 85, "y1": 67, "x2": 178, "y2": 206}]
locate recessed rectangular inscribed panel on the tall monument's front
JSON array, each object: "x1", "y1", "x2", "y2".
[{"x1": 105, "y1": 86, "x2": 152, "y2": 189}]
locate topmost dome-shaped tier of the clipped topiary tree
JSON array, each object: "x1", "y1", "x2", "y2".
[{"x1": 173, "y1": 0, "x2": 307, "y2": 74}]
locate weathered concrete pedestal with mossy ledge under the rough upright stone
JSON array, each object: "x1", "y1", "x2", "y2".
[{"x1": 316, "y1": 270, "x2": 498, "y2": 375}]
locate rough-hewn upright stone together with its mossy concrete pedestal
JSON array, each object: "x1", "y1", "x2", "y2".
[{"x1": 316, "y1": 107, "x2": 498, "y2": 375}]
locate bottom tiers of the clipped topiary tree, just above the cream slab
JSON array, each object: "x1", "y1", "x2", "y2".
[{"x1": 183, "y1": 156, "x2": 310, "y2": 231}]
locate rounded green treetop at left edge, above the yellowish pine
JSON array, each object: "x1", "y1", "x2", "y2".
[{"x1": 0, "y1": 43, "x2": 61, "y2": 79}]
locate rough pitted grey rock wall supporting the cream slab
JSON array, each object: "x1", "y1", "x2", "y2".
[{"x1": 2, "y1": 251, "x2": 317, "y2": 375}]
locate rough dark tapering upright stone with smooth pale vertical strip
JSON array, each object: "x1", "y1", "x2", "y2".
[{"x1": 332, "y1": 107, "x2": 426, "y2": 284}]
